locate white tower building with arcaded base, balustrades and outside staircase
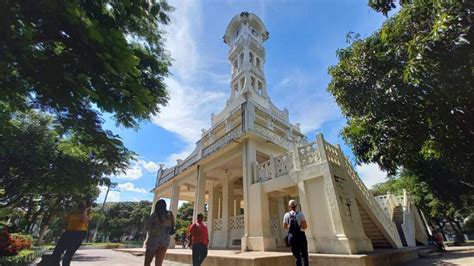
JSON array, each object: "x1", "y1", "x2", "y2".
[{"x1": 154, "y1": 12, "x2": 426, "y2": 254}]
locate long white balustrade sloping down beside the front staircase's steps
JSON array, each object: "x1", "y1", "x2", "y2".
[{"x1": 340, "y1": 155, "x2": 402, "y2": 247}]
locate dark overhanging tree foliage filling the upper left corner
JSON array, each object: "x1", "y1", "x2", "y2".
[{"x1": 0, "y1": 0, "x2": 171, "y2": 171}]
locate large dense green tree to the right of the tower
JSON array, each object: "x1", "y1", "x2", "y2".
[{"x1": 328, "y1": 0, "x2": 474, "y2": 193}]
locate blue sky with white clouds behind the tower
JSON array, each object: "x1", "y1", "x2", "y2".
[{"x1": 98, "y1": 0, "x2": 392, "y2": 202}]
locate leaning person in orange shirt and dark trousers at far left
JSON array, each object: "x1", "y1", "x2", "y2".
[{"x1": 52, "y1": 200, "x2": 91, "y2": 266}]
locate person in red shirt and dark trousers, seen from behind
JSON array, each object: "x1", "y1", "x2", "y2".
[{"x1": 189, "y1": 213, "x2": 209, "y2": 266}]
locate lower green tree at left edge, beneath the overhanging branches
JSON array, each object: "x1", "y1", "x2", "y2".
[{"x1": 0, "y1": 111, "x2": 115, "y2": 243}]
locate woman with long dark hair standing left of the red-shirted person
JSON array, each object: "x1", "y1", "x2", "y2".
[{"x1": 145, "y1": 199, "x2": 175, "y2": 266}]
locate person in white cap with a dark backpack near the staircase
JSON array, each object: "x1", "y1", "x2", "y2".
[{"x1": 283, "y1": 200, "x2": 309, "y2": 266}]
